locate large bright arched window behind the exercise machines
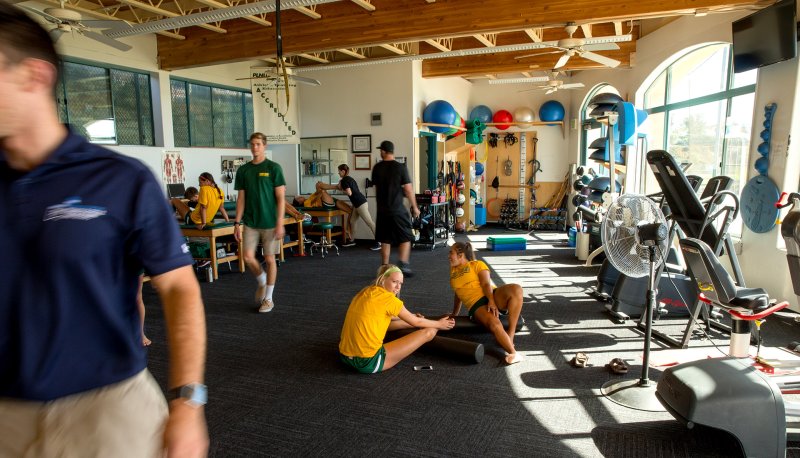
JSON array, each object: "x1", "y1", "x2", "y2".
[{"x1": 643, "y1": 43, "x2": 757, "y2": 233}]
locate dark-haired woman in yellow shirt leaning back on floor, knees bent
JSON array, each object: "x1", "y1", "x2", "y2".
[{"x1": 449, "y1": 242, "x2": 522, "y2": 364}]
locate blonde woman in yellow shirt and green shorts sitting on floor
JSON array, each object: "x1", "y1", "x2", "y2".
[{"x1": 339, "y1": 264, "x2": 455, "y2": 374}]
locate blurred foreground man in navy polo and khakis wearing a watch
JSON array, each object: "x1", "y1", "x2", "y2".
[{"x1": 0, "y1": 2, "x2": 208, "y2": 456}]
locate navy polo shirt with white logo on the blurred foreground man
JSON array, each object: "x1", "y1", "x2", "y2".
[{"x1": 0, "y1": 132, "x2": 192, "y2": 401}]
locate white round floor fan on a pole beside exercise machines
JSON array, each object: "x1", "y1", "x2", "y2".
[{"x1": 601, "y1": 194, "x2": 668, "y2": 412}]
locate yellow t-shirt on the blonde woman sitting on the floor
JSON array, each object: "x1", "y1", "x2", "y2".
[{"x1": 339, "y1": 286, "x2": 403, "y2": 358}]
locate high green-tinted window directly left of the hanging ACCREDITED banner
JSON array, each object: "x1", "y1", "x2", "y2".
[{"x1": 170, "y1": 79, "x2": 253, "y2": 148}]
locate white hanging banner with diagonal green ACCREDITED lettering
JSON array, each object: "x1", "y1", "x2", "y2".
[{"x1": 250, "y1": 67, "x2": 300, "y2": 144}]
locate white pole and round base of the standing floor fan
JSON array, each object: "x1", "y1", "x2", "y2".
[{"x1": 600, "y1": 245, "x2": 666, "y2": 412}]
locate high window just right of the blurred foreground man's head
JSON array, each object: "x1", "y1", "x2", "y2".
[{"x1": 56, "y1": 62, "x2": 155, "y2": 145}]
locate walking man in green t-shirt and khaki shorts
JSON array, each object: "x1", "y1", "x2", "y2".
[{"x1": 233, "y1": 132, "x2": 286, "y2": 313}]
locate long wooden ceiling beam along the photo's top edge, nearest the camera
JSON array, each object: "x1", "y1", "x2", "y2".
[{"x1": 158, "y1": 0, "x2": 757, "y2": 70}]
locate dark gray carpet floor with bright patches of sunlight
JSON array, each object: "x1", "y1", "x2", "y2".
[{"x1": 145, "y1": 229, "x2": 800, "y2": 457}]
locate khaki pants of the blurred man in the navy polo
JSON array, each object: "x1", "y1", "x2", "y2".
[{"x1": 0, "y1": 369, "x2": 169, "y2": 458}]
